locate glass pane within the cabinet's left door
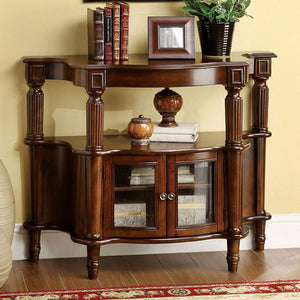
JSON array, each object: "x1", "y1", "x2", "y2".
[{"x1": 114, "y1": 166, "x2": 155, "y2": 227}]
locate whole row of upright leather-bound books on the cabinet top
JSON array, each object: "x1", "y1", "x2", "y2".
[{"x1": 87, "y1": 2, "x2": 129, "y2": 61}]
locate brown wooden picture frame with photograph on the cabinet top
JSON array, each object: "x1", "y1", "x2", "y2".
[{"x1": 148, "y1": 17, "x2": 195, "y2": 59}]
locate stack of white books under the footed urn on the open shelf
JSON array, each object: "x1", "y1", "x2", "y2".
[{"x1": 150, "y1": 122, "x2": 198, "y2": 143}]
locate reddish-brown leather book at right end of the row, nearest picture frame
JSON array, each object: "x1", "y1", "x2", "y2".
[{"x1": 120, "y1": 2, "x2": 129, "y2": 60}]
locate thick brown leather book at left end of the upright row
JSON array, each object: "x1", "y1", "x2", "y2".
[{"x1": 88, "y1": 9, "x2": 104, "y2": 60}]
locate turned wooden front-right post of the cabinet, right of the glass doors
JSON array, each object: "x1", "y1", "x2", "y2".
[{"x1": 225, "y1": 67, "x2": 247, "y2": 272}]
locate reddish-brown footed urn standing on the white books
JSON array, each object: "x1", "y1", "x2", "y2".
[{"x1": 153, "y1": 88, "x2": 182, "y2": 127}]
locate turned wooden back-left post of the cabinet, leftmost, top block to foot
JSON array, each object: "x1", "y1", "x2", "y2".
[{"x1": 25, "y1": 63, "x2": 46, "y2": 262}]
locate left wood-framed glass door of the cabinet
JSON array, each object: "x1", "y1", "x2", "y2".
[{"x1": 104, "y1": 156, "x2": 165, "y2": 237}]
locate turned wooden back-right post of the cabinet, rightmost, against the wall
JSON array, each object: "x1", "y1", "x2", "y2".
[{"x1": 249, "y1": 53, "x2": 276, "y2": 251}]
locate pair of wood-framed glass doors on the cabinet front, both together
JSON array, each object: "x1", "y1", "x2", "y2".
[{"x1": 104, "y1": 151, "x2": 225, "y2": 238}]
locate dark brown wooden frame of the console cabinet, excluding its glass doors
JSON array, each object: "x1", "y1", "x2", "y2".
[{"x1": 23, "y1": 53, "x2": 276, "y2": 278}]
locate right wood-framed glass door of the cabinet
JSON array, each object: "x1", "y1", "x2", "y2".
[{"x1": 167, "y1": 152, "x2": 224, "y2": 236}]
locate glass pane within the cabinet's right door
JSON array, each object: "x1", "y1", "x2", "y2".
[{"x1": 177, "y1": 162, "x2": 214, "y2": 227}]
